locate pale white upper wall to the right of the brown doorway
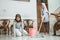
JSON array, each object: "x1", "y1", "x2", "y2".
[{"x1": 48, "y1": 0, "x2": 60, "y2": 13}]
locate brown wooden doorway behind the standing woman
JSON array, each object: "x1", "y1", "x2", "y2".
[{"x1": 37, "y1": 0, "x2": 49, "y2": 32}]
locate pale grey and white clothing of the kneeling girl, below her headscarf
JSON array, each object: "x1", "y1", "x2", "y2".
[{"x1": 13, "y1": 20, "x2": 28, "y2": 36}]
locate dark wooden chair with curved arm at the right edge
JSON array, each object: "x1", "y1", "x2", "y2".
[{"x1": 52, "y1": 13, "x2": 60, "y2": 35}]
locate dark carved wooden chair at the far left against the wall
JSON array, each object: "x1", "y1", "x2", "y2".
[{"x1": 0, "y1": 19, "x2": 10, "y2": 34}]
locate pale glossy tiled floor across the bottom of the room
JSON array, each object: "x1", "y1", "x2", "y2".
[{"x1": 0, "y1": 34, "x2": 60, "y2": 40}]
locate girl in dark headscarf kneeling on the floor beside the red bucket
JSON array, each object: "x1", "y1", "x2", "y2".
[{"x1": 13, "y1": 14, "x2": 28, "y2": 36}]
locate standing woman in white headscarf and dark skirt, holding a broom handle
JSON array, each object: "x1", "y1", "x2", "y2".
[{"x1": 41, "y1": 3, "x2": 49, "y2": 33}]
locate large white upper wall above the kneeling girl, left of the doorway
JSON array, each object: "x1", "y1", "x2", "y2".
[{"x1": 0, "y1": 0, "x2": 36, "y2": 19}]
